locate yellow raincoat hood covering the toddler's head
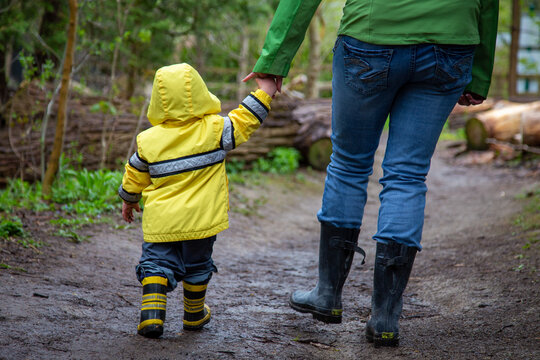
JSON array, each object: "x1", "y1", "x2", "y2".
[{"x1": 147, "y1": 64, "x2": 221, "y2": 126}]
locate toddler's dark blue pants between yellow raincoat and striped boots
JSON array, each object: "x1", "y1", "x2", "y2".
[{"x1": 135, "y1": 235, "x2": 217, "y2": 291}]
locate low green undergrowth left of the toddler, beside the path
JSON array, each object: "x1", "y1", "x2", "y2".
[{"x1": 0, "y1": 157, "x2": 122, "y2": 248}]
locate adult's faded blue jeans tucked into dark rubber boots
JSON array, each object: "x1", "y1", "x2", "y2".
[{"x1": 317, "y1": 36, "x2": 474, "y2": 250}]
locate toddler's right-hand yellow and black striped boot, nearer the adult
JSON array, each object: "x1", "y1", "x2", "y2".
[{"x1": 180, "y1": 281, "x2": 210, "y2": 330}]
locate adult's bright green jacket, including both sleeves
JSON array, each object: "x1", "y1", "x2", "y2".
[{"x1": 253, "y1": 0, "x2": 499, "y2": 97}]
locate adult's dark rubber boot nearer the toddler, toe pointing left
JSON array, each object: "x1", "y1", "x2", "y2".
[{"x1": 289, "y1": 223, "x2": 366, "y2": 324}]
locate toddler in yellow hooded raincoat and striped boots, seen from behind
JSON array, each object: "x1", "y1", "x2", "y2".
[{"x1": 118, "y1": 64, "x2": 276, "y2": 338}]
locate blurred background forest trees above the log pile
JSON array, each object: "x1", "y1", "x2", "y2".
[{"x1": 0, "y1": 0, "x2": 540, "y2": 104}]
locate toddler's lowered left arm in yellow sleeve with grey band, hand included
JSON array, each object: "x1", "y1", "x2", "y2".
[{"x1": 118, "y1": 139, "x2": 151, "y2": 222}]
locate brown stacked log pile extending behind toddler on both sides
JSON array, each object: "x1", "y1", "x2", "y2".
[{"x1": 0, "y1": 84, "x2": 331, "y2": 184}]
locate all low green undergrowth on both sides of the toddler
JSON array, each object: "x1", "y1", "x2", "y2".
[{"x1": 0, "y1": 148, "x2": 300, "y2": 245}]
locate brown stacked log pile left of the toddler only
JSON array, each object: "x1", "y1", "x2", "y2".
[{"x1": 0, "y1": 83, "x2": 150, "y2": 183}]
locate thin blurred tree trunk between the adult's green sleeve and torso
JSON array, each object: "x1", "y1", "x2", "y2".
[{"x1": 304, "y1": 9, "x2": 321, "y2": 99}]
